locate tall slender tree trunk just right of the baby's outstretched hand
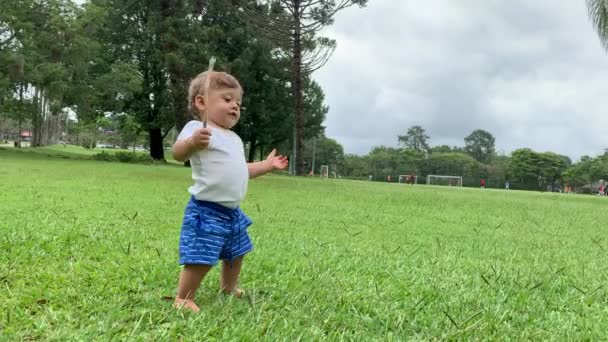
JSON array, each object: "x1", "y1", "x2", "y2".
[{"x1": 291, "y1": 0, "x2": 305, "y2": 175}]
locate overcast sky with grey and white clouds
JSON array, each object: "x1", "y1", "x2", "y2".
[{"x1": 314, "y1": 0, "x2": 608, "y2": 161}]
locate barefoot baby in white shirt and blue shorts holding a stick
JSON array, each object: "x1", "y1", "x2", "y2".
[{"x1": 173, "y1": 72, "x2": 288, "y2": 312}]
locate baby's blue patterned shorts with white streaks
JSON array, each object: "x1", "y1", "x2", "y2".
[{"x1": 179, "y1": 197, "x2": 253, "y2": 266}]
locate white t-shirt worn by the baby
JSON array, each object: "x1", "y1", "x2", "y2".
[{"x1": 177, "y1": 120, "x2": 249, "y2": 208}]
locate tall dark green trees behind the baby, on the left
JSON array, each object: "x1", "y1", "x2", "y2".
[{"x1": 0, "y1": 0, "x2": 366, "y2": 173}]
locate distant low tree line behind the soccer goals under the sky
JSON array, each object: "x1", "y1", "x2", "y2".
[{"x1": 307, "y1": 126, "x2": 608, "y2": 192}]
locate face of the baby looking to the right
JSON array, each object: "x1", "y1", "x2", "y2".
[{"x1": 201, "y1": 88, "x2": 241, "y2": 129}]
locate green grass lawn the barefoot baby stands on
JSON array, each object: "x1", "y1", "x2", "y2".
[{"x1": 0, "y1": 150, "x2": 608, "y2": 341}]
